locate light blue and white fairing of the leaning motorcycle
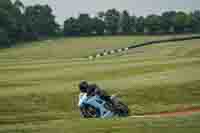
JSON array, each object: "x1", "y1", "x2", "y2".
[{"x1": 78, "y1": 93, "x2": 115, "y2": 118}]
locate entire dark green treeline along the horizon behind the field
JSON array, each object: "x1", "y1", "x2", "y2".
[{"x1": 0, "y1": 0, "x2": 200, "y2": 47}]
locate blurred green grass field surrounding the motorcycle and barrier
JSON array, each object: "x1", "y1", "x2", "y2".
[{"x1": 0, "y1": 36, "x2": 200, "y2": 133}]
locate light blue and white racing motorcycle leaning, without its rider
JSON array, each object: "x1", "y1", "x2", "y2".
[{"x1": 78, "y1": 94, "x2": 130, "y2": 118}]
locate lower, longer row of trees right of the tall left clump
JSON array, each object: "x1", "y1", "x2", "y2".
[{"x1": 64, "y1": 9, "x2": 200, "y2": 35}]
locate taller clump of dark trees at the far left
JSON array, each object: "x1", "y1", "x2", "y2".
[{"x1": 0, "y1": 0, "x2": 59, "y2": 47}]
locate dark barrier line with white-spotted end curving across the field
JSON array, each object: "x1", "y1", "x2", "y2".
[{"x1": 88, "y1": 36, "x2": 200, "y2": 60}]
